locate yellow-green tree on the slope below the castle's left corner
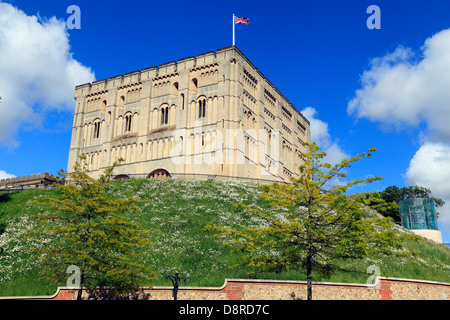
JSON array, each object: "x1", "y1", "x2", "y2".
[{"x1": 29, "y1": 157, "x2": 153, "y2": 299}]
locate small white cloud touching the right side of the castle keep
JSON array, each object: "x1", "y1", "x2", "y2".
[{"x1": 301, "y1": 107, "x2": 349, "y2": 164}]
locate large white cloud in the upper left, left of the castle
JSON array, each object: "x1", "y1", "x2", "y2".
[{"x1": 0, "y1": 2, "x2": 95, "y2": 146}]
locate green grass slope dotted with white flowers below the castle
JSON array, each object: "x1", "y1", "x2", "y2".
[{"x1": 0, "y1": 179, "x2": 450, "y2": 296}]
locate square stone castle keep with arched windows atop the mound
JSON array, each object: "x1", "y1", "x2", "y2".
[{"x1": 68, "y1": 46, "x2": 310, "y2": 183}]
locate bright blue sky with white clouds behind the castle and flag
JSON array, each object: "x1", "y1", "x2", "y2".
[{"x1": 0, "y1": 0, "x2": 450, "y2": 242}]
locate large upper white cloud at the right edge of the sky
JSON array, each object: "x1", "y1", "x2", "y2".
[{"x1": 347, "y1": 29, "x2": 450, "y2": 141}]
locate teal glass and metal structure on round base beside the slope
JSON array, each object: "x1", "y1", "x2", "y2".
[{"x1": 398, "y1": 198, "x2": 438, "y2": 230}]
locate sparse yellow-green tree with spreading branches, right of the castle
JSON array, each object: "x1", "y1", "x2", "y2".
[{"x1": 206, "y1": 143, "x2": 414, "y2": 300}]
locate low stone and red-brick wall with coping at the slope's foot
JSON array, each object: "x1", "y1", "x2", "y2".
[{"x1": 0, "y1": 277, "x2": 450, "y2": 300}]
